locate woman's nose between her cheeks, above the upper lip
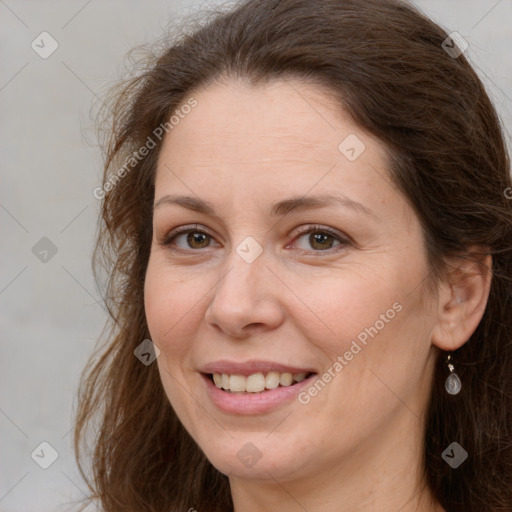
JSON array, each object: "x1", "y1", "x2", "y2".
[{"x1": 205, "y1": 246, "x2": 285, "y2": 339}]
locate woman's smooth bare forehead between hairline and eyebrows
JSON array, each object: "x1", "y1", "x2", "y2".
[{"x1": 152, "y1": 80, "x2": 396, "y2": 217}]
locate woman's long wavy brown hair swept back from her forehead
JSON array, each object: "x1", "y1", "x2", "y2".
[{"x1": 75, "y1": 0, "x2": 512, "y2": 512}]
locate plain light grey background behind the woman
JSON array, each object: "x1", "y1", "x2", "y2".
[{"x1": 0, "y1": 0, "x2": 512, "y2": 512}]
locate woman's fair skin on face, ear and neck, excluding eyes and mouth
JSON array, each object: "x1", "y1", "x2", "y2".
[{"x1": 145, "y1": 79, "x2": 489, "y2": 512}]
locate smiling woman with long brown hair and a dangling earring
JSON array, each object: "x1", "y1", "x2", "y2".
[{"x1": 75, "y1": 0, "x2": 512, "y2": 512}]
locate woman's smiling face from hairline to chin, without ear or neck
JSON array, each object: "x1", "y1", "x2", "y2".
[{"x1": 145, "y1": 80, "x2": 435, "y2": 482}]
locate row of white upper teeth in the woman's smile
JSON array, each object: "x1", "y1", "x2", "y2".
[{"x1": 213, "y1": 372, "x2": 312, "y2": 393}]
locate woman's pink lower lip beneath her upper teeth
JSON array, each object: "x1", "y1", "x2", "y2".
[{"x1": 201, "y1": 374, "x2": 316, "y2": 414}]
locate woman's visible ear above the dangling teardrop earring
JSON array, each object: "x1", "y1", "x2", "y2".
[{"x1": 432, "y1": 246, "x2": 492, "y2": 352}]
